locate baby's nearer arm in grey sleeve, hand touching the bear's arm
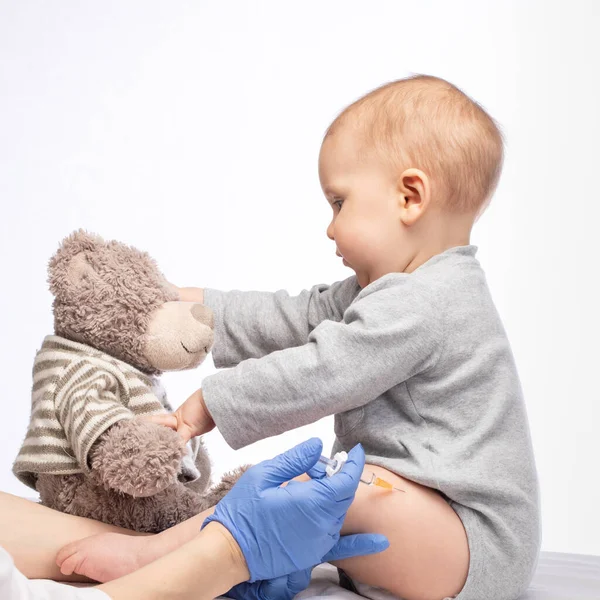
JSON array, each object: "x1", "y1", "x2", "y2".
[{"x1": 164, "y1": 279, "x2": 442, "y2": 449}]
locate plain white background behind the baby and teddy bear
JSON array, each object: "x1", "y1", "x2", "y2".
[{"x1": 0, "y1": 0, "x2": 600, "y2": 554}]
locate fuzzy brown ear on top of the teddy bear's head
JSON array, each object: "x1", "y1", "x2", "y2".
[{"x1": 48, "y1": 229, "x2": 105, "y2": 296}]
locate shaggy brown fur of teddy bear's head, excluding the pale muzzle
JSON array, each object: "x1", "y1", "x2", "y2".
[{"x1": 48, "y1": 231, "x2": 179, "y2": 373}]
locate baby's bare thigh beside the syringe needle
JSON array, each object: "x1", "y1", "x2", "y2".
[{"x1": 335, "y1": 465, "x2": 469, "y2": 600}]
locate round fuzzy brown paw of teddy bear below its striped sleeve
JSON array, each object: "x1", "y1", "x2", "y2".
[{"x1": 91, "y1": 419, "x2": 186, "y2": 497}]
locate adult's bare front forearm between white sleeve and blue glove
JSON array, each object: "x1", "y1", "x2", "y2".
[{"x1": 98, "y1": 522, "x2": 250, "y2": 600}]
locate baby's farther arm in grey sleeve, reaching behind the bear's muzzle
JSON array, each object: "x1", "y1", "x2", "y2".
[{"x1": 180, "y1": 277, "x2": 360, "y2": 367}]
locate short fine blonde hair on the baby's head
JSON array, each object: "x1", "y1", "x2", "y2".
[{"x1": 323, "y1": 75, "x2": 504, "y2": 212}]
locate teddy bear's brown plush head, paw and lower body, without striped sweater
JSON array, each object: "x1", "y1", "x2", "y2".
[{"x1": 31, "y1": 231, "x2": 244, "y2": 532}]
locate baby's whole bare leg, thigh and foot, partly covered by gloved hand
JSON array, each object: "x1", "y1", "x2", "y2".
[{"x1": 52, "y1": 465, "x2": 469, "y2": 600}]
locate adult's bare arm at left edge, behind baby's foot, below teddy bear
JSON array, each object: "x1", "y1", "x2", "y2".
[{"x1": 0, "y1": 492, "x2": 135, "y2": 581}]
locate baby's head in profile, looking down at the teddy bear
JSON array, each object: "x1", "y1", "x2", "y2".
[{"x1": 319, "y1": 75, "x2": 503, "y2": 287}]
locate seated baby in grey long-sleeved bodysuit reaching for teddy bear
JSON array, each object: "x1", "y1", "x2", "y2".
[{"x1": 58, "y1": 76, "x2": 540, "y2": 600}]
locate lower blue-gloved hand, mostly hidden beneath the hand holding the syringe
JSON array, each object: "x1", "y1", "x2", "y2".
[{"x1": 227, "y1": 535, "x2": 389, "y2": 600}]
